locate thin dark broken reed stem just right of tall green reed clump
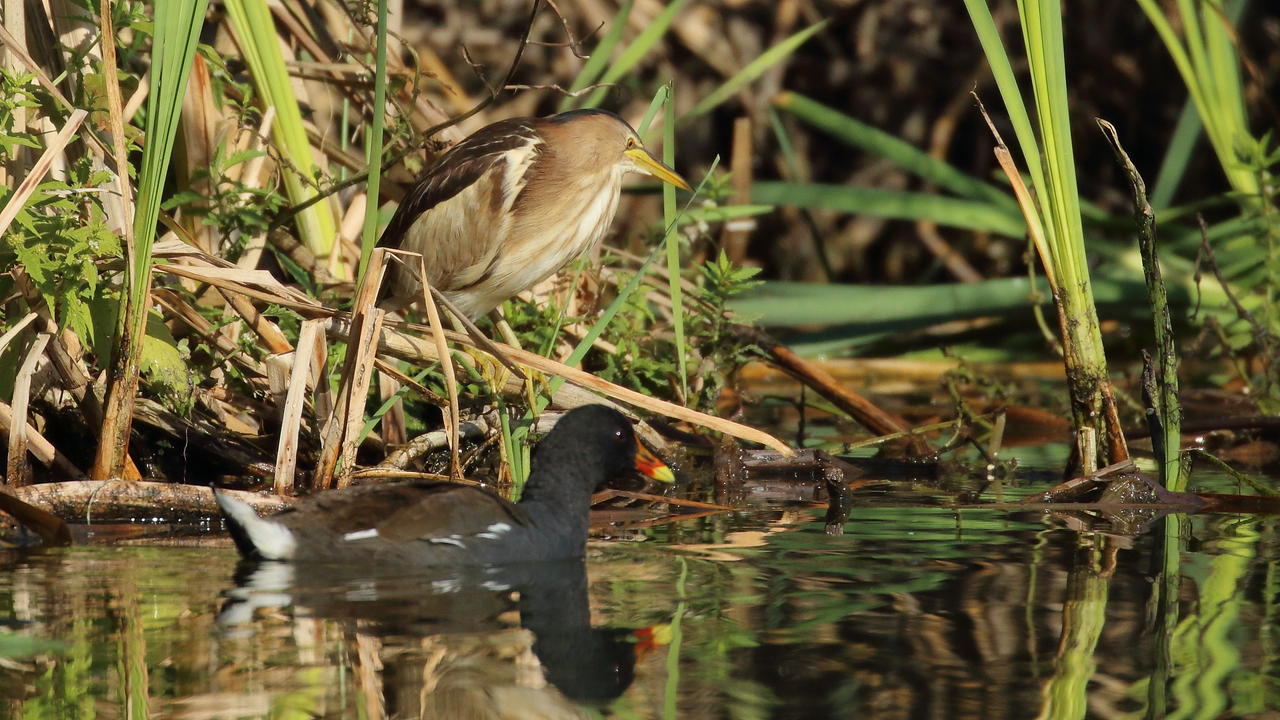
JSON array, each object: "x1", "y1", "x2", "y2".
[{"x1": 1097, "y1": 118, "x2": 1187, "y2": 492}]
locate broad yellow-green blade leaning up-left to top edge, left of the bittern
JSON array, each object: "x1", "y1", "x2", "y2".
[{"x1": 224, "y1": 0, "x2": 349, "y2": 278}]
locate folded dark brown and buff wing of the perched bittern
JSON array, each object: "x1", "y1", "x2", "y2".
[{"x1": 378, "y1": 118, "x2": 539, "y2": 304}]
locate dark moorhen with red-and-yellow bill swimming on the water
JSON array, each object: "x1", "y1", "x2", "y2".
[{"x1": 214, "y1": 405, "x2": 675, "y2": 566}]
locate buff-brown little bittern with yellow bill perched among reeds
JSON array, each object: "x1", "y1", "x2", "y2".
[{"x1": 378, "y1": 110, "x2": 690, "y2": 319}]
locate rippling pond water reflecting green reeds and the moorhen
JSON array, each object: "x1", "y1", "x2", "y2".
[{"x1": 0, "y1": 461, "x2": 1280, "y2": 720}]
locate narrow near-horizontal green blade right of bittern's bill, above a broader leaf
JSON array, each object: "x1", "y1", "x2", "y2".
[{"x1": 751, "y1": 182, "x2": 1027, "y2": 237}]
